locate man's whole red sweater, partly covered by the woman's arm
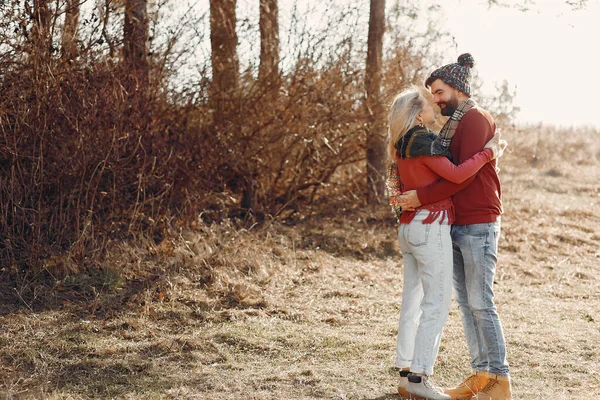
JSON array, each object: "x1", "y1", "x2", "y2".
[{"x1": 417, "y1": 107, "x2": 502, "y2": 225}]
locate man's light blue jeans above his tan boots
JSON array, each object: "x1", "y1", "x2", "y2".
[{"x1": 451, "y1": 218, "x2": 509, "y2": 376}]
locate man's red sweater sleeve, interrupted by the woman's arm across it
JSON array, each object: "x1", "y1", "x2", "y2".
[{"x1": 417, "y1": 110, "x2": 494, "y2": 204}]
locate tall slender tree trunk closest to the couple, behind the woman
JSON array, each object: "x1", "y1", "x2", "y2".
[{"x1": 365, "y1": 0, "x2": 386, "y2": 204}]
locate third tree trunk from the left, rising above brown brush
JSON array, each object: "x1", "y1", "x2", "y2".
[{"x1": 123, "y1": 0, "x2": 149, "y2": 92}]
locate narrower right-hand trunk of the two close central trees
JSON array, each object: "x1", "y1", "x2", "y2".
[{"x1": 258, "y1": 0, "x2": 280, "y2": 94}]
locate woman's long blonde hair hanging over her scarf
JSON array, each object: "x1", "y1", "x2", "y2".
[{"x1": 388, "y1": 86, "x2": 427, "y2": 164}]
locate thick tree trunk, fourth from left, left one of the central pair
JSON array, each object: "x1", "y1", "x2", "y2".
[{"x1": 210, "y1": 0, "x2": 239, "y2": 126}]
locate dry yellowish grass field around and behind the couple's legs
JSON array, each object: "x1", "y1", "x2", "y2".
[{"x1": 0, "y1": 128, "x2": 600, "y2": 400}]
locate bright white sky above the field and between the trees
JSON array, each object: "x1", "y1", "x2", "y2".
[{"x1": 190, "y1": 0, "x2": 600, "y2": 128}]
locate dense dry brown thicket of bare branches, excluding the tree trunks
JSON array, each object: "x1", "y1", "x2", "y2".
[{"x1": 0, "y1": 1, "x2": 516, "y2": 280}]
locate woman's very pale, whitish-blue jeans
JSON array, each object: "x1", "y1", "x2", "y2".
[{"x1": 396, "y1": 210, "x2": 452, "y2": 375}]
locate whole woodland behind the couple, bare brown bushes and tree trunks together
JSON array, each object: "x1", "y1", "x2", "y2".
[{"x1": 0, "y1": 0, "x2": 515, "y2": 277}]
